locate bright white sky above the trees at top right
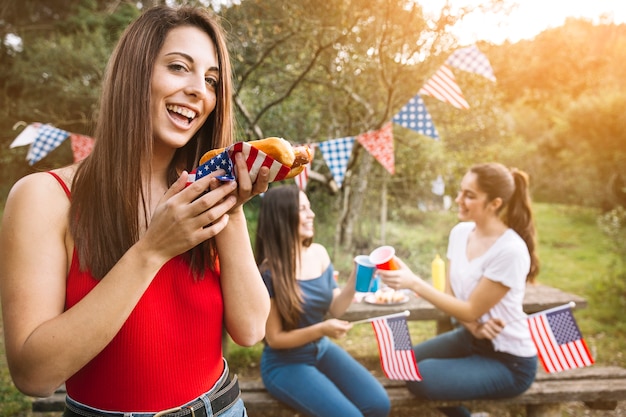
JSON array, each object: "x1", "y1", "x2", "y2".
[{"x1": 419, "y1": 0, "x2": 626, "y2": 44}]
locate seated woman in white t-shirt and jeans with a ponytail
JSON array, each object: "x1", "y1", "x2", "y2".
[{"x1": 378, "y1": 163, "x2": 539, "y2": 417}]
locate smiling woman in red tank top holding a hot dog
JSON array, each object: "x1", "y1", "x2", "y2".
[{"x1": 0, "y1": 6, "x2": 269, "y2": 417}]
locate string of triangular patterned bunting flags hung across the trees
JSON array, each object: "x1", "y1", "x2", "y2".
[{"x1": 10, "y1": 45, "x2": 496, "y2": 189}]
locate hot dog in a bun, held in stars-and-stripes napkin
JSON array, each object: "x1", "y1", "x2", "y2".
[{"x1": 200, "y1": 137, "x2": 313, "y2": 179}]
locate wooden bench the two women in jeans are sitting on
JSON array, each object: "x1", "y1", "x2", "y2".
[{"x1": 32, "y1": 365, "x2": 626, "y2": 417}]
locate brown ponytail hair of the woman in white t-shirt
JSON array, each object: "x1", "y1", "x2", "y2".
[{"x1": 470, "y1": 162, "x2": 539, "y2": 282}]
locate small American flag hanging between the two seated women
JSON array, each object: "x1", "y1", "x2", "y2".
[{"x1": 372, "y1": 315, "x2": 422, "y2": 381}]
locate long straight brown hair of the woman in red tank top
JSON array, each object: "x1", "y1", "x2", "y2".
[{"x1": 70, "y1": 6, "x2": 234, "y2": 278}]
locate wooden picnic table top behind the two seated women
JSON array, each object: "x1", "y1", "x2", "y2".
[{"x1": 341, "y1": 284, "x2": 587, "y2": 326}]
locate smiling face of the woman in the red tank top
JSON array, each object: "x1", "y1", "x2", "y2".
[{"x1": 150, "y1": 26, "x2": 220, "y2": 149}]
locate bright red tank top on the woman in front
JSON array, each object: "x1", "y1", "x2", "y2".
[{"x1": 50, "y1": 171, "x2": 224, "y2": 412}]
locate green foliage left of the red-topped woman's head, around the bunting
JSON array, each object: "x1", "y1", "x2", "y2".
[{"x1": 0, "y1": 0, "x2": 138, "y2": 201}]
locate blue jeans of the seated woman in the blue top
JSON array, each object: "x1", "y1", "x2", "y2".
[{"x1": 261, "y1": 337, "x2": 391, "y2": 417}]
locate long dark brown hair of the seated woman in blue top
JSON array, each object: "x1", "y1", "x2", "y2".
[{"x1": 254, "y1": 185, "x2": 311, "y2": 330}]
